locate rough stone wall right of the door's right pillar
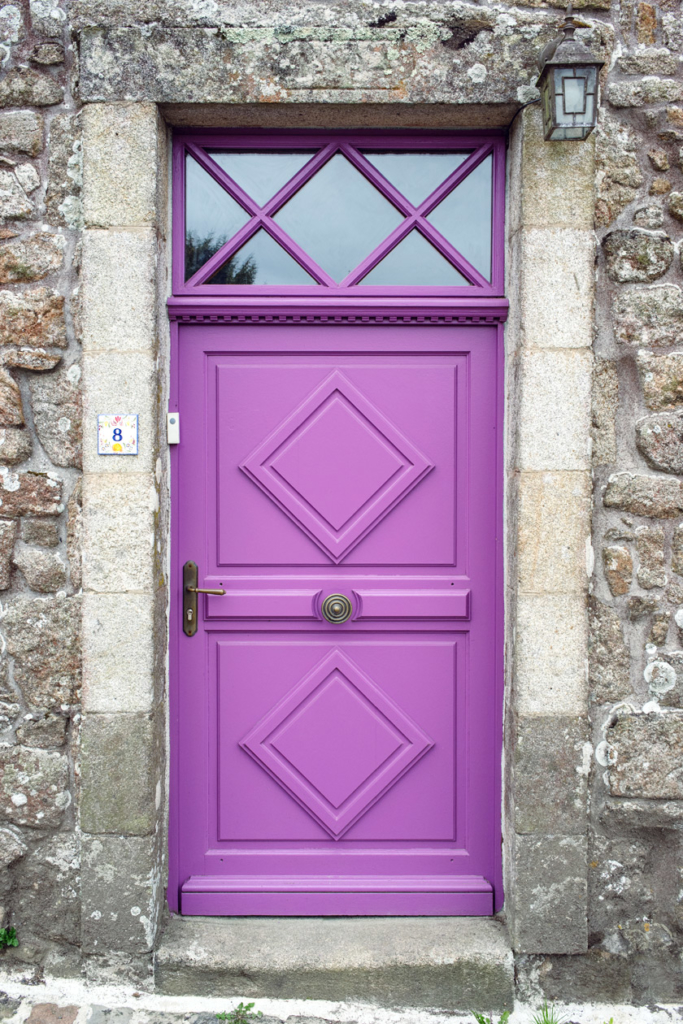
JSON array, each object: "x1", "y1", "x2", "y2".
[{"x1": 518, "y1": 0, "x2": 683, "y2": 1004}]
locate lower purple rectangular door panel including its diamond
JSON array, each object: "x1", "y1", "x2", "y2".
[{"x1": 213, "y1": 636, "x2": 458, "y2": 848}]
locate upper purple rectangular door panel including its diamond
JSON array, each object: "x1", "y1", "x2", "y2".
[{"x1": 207, "y1": 354, "x2": 467, "y2": 570}]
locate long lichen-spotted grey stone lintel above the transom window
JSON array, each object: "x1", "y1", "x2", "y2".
[{"x1": 78, "y1": 12, "x2": 557, "y2": 106}]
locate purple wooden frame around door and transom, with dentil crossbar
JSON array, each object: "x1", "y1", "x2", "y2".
[{"x1": 167, "y1": 129, "x2": 509, "y2": 913}]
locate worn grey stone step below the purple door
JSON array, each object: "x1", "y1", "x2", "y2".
[{"x1": 156, "y1": 916, "x2": 514, "y2": 1012}]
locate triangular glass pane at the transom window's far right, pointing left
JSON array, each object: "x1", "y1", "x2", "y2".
[{"x1": 427, "y1": 157, "x2": 494, "y2": 281}]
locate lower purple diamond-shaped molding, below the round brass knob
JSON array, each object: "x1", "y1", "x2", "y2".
[{"x1": 240, "y1": 648, "x2": 433, "y2": 840}]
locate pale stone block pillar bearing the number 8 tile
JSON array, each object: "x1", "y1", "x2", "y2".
[{"x1": 80, "y1": 103, "x2": 167, "y2": 954}]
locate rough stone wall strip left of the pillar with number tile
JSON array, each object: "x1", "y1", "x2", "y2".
[{"x1": 0, "y1": 2, "x2": 82, "y2": 971}]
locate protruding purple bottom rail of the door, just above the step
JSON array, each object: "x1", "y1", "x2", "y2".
[{"x1": 180, "y1": 874, "x2": 494, "y2": 916}]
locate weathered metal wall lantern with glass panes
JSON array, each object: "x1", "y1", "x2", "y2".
[{"x1": 536, "y1": 4, "x2": 604, "y2": 142}]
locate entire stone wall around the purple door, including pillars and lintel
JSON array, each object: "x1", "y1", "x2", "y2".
[{"x1": 0, "y1": 0, "x2": 683, "y2": 1002}]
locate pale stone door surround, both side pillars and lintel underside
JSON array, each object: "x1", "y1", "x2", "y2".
[{"x1": 80, "y1": 97, "x2": 596, "y2": 954}]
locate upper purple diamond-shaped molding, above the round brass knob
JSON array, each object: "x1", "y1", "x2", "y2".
[{"x1": 240, "y1": 370, "x2": 434, "y2": 562}]
